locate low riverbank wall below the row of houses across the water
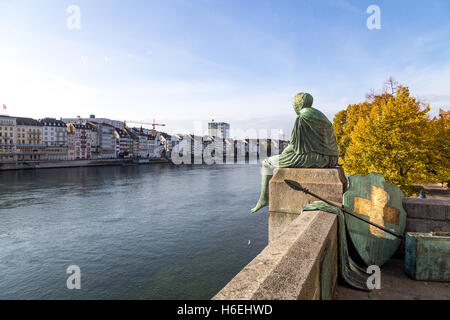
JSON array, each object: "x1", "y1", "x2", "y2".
[{"x1": 0, "y1": 158, "x2": 169, "y2": 171}]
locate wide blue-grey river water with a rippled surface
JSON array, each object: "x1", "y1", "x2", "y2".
[{"x1": 0, "y1": 164, "x2": 267, "y2": 299}]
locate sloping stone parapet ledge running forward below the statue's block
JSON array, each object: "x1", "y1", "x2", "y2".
[{"x1": 213, "y1": 211, "x2": 338, "y2": 300}]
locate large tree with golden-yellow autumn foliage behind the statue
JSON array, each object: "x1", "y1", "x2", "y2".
[{"x1": 333, "y1": 79, "x2": 450, "y2": 196}]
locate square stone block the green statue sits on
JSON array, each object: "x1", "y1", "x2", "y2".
[{"x1": 269, "y1": 168, "x2": 347, "y2": 214}]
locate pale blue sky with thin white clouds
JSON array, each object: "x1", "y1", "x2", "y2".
[{"x1": 0, "y1": 0, "x2": 450, "y2": 135}]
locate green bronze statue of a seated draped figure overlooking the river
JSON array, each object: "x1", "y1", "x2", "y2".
[{"x1": 252, "y1": 93, "x2": 339, "y2": 212}]
